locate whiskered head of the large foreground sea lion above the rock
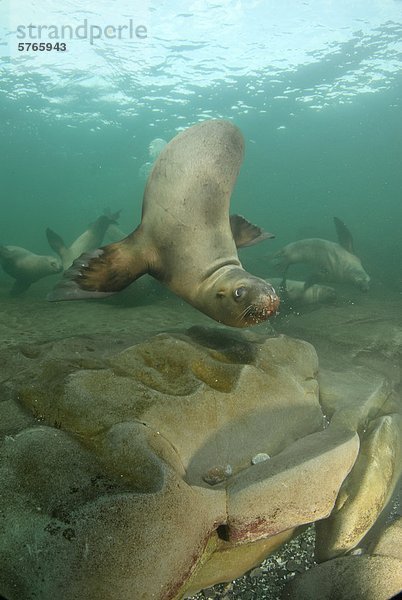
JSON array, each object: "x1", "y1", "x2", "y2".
[{"x1": 199, "y1": 267, "x2": 279, "y2": 327}]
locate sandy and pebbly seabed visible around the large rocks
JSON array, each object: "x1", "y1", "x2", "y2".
[{"x1": 0, "y1": 278, "x2": 402, "y2": 600}]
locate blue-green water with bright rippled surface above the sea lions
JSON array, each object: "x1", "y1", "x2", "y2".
[{"x1": 0, "y1": 2, "x2": 402, "y2": 290}]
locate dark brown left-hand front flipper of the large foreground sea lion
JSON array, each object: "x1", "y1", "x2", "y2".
[{"x1": 47, "y1": 230, "x2": 152, "y2": 302}]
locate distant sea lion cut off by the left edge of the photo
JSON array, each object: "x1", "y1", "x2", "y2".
[{"x1": 0, "y1": 246, "x2": 63, "y2": 296}]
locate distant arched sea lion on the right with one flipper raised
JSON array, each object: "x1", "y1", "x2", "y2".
[{"x1": 273, "y1": 217, "x2": 370, "y2": 291}]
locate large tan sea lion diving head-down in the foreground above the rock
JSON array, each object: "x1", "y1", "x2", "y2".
[{"x1": 49, "y1": 120, "x2": 279, "y2": 327}]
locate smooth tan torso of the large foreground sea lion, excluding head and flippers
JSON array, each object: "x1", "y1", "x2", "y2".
[{"x1": 141, "y1": 122, "x2": 254, "y2": 308}]
